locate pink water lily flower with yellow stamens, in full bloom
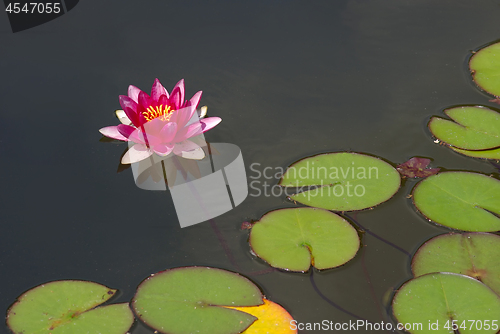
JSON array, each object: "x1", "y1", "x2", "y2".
[{"x1": 99, "y1": 79, "x2": 221, "y2": 164}]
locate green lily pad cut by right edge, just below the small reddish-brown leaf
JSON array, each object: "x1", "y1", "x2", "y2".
[{"x1": 413, "y1": 172, "x2": 500, "y2": 232}]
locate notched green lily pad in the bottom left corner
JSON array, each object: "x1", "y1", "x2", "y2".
[{"x1": 7, "y1": 281, "x2": 134, "y2": 334}]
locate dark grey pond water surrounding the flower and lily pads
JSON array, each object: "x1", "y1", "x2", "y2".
[{"x1": 0, "y1": 0, "x2": 500, "y2": 334}]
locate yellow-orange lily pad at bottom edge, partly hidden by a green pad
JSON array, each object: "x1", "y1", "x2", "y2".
[{"x1": 226, "y1": 299, "x2": 297, "y2": 334}]
